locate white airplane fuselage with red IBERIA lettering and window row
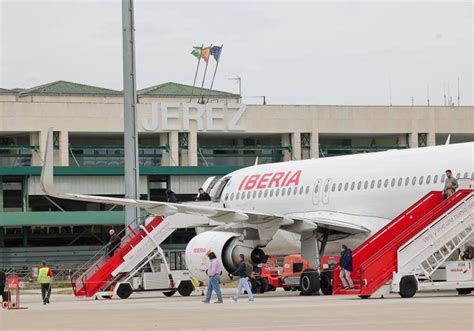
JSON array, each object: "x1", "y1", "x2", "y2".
[{"x1": 206, "y1": 143, "x2": 474, "y2": 254}]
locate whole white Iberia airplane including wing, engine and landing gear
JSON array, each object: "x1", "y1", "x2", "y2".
[{"x1": 41, "y1": 130, "x2": 474, "y2": 294}]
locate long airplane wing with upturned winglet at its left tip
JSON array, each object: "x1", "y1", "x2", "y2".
[{"x1": 41, "y1": 129, "x2": 368, "y2": 234}]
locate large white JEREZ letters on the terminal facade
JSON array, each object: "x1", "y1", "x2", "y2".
[{"x1": 141, "y1": 102, "x2": 246, "y2": 131}]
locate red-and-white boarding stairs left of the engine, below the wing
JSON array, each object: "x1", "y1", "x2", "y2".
[{"x1": 71, "y1": 216, "x2": 176, "y2": 297}]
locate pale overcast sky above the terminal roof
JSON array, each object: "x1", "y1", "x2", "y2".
[{"x1": 0, "y1": 0, "x2": 473, "y2": 105}]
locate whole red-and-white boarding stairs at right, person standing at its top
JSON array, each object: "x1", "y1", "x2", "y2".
[{"x1": 333, "y1": 188, "x2": 474, "y2": 298}]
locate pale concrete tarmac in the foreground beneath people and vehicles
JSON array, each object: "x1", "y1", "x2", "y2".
[{"x1": 0, "y1": 289, "x2": 474, "y2": 331}]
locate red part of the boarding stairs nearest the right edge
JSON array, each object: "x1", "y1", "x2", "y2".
[{"x1": 333, "y1": 190, "x2": 471, "y2": 296}]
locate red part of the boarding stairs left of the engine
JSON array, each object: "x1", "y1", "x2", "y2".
[{"x1": 73, "y1": 217, "x2": 163, "y2": 297}]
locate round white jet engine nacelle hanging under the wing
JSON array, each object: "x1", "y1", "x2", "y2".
[{"x1": 185, "y1": 231, "x2": 254, "y2": 283}]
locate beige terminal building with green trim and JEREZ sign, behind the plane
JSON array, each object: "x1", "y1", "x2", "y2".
[{"x1": 0, "y1": 81, "x2": 474, "y2": 267}]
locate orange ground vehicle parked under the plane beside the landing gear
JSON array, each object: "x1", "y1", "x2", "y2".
[{"x1": 251, "y1": 254, "x2": 339, "y2": 295}]
